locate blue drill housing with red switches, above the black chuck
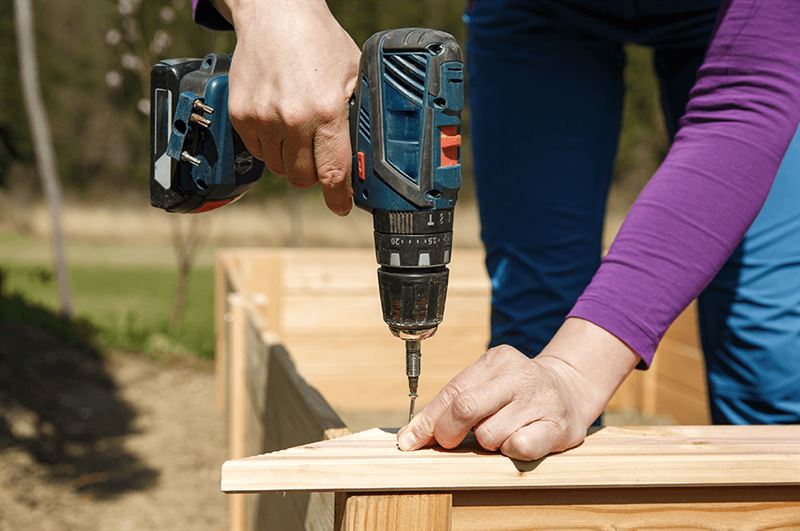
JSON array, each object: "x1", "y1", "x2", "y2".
[{"x1": 351, "y1": 42, "x2": 464, "y2": 211}]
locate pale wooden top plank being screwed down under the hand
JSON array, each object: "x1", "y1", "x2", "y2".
[{"x1": 222, "y1": 426, "x2": 800, "y2": 492}]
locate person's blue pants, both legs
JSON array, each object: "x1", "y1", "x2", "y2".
[{"x1": 467, "y1": 0, "x2": 800, "y2": 424}]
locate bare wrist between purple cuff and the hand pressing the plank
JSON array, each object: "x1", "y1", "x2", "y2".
[{"x1": 536, "y1": 318, "x2": 640, "y2": 426}]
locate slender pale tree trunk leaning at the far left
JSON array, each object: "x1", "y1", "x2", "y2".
[{"x1": 14, "y1": 0, "x2": 73, "y2": 318}]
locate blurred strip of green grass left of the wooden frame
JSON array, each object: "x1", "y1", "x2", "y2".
[{"x1": 0, "y1": 263, "x2": 214, "y2": 358}]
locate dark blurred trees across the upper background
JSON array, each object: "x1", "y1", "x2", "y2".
[{"x1": 0, "y1": 0, "x2": 666, "y2": 204}]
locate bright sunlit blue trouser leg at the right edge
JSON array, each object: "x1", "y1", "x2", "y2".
[{"x1": 699, "y1": 129, "x2": 800, "y2": 424}]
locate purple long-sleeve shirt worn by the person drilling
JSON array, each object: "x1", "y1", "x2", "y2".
[{"x1": 192, "y1": 0, "x2": 800, "y2": 365}]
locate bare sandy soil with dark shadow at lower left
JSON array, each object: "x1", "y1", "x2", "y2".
[{"x1": 0, "y1": 352, "x2": 226, "y2": 531}]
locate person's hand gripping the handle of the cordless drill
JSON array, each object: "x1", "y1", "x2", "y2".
[{"x1": 215, "y1": 0, "x2": 361, "y2": 215}]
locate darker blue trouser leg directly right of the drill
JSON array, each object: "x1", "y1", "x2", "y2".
[{"x1": 468, "y1": 2, "x2": 624, "y2": 356}]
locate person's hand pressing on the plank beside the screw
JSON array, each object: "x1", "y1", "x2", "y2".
[{"x1": 398, "y1": 319, "x2": 639, "y2": 461}]
